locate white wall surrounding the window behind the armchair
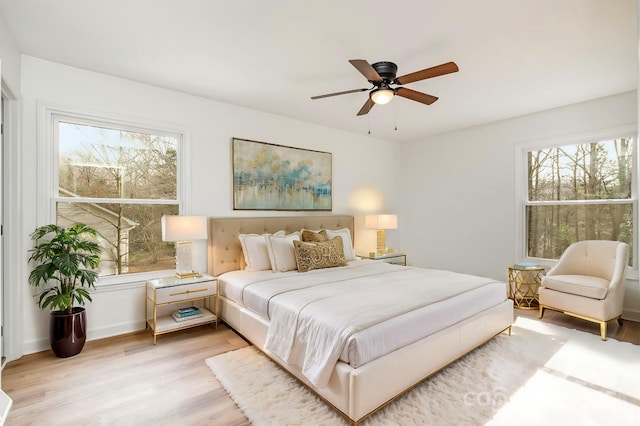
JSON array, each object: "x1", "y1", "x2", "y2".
[{"x1": 395, "y1": 91, "x2": 640, "y2": 319}]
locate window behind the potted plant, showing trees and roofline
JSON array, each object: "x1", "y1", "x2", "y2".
[{"x1": 51, "y1": 114, "x2": 182, "y2": 276}]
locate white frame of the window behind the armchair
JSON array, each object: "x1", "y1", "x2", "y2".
[{"x1": 514, "y1": 124, "x2": 640, "y2": 279}]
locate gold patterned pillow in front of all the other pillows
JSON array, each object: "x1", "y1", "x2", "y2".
[{"x1": 293, "y1": 236, "x2": 347, "y2": 272}]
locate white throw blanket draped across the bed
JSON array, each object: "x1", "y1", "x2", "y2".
[{"x1": 265, "y1": 262, "x2": 495, "y2": 388}]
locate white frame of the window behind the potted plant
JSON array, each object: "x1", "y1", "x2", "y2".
[{"x1": 36, "y1": 103, "x2": 191, "y2": 287}]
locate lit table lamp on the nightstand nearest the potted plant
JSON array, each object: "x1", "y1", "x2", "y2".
[{"x1": 162, "y1": 215, "x2": 207, "y2": 278}]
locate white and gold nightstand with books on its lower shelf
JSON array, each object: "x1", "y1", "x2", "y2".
[{"x1": 145, "y1": 274, "x2": 218, "y2": 345}]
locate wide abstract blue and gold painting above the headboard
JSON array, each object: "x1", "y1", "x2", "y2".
[{"x1": 232, "y1": 138, "x2": 333, "y2": 211}]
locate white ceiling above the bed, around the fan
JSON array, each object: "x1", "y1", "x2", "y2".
[{"x1": 0, "y1": 0, "x2": 638, "y2": 142}]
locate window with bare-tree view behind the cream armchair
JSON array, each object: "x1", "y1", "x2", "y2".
[{"x1": 523, "y1": 132, "x2": 637, "y2": 266}]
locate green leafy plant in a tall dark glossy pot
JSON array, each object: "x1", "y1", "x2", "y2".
[{"x1": 29, "y1": 224, "x2": 102, "y2": 358}]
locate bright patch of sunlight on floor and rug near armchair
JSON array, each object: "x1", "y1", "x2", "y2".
[{"x1": 488, "y1": 317, "x2": 640, "y2": 425}]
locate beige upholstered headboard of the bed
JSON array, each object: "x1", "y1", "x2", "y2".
[{"x1": 207, "y1": 215, "x2": 355, "y2": 276}]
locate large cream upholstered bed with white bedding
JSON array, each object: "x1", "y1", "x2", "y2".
[{"x1": 208, "y1": 215, "x2": 513, "y2": 425}]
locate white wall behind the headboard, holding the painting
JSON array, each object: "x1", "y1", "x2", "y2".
[{"x1": 16, "y1": 56, "x2": 398, "y2": 353}]
